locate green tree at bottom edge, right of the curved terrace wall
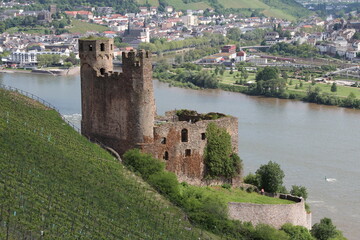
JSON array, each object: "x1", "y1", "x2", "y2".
[{"x1": 310, "y1": 218, "x2": 342, "y2": 240}]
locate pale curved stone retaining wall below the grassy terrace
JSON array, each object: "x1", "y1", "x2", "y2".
[{"x1": 228, "y1": 200, "x2": 311, "y2": 229}]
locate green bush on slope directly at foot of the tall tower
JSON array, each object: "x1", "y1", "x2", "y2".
[{"x1": 123, "y1": 149, "x2": 165, "y2": 180}]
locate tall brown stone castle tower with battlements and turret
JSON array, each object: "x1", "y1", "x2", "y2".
[{"x1": 79, "y1": 38, "x2": 155, "y2": 154}]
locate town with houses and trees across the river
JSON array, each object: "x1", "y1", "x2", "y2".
[{"x1": 0, "y1": 1, "x2": 360, "y2": 108}]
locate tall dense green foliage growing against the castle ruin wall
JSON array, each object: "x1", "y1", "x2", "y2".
[{"x1": 205, "y1": 123, "x2": 242, "y2": 179}]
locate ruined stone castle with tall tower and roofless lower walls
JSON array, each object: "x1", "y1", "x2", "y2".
[{"x1": 79, "y1": 38, "x2": 238, "y2": 185}]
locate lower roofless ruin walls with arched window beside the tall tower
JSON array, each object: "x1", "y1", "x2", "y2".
[{"x1": 141, "y1": 117, "x2": 238, "y2": 185}]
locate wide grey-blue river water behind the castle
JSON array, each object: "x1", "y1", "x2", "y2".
[{"x1": 0, "y1": 73, "x2": 360, "y2": 240}]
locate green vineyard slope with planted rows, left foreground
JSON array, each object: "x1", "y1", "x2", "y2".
[{"x1": 0, "y1": 89, "x2": 208, "y2": 239}]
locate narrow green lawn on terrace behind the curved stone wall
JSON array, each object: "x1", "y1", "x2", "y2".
[{"x1": 181, "y1": 186, "x2": 294, "y2": 204}]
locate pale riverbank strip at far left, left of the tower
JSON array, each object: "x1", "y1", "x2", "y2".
[{"x1": 0, "y1": 66, "x2": 80, "y2": 76}]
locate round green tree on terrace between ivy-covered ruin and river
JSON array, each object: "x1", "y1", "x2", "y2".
[{"x1": 256, "y1": 161, "x2": 285, "y2": 193}]
